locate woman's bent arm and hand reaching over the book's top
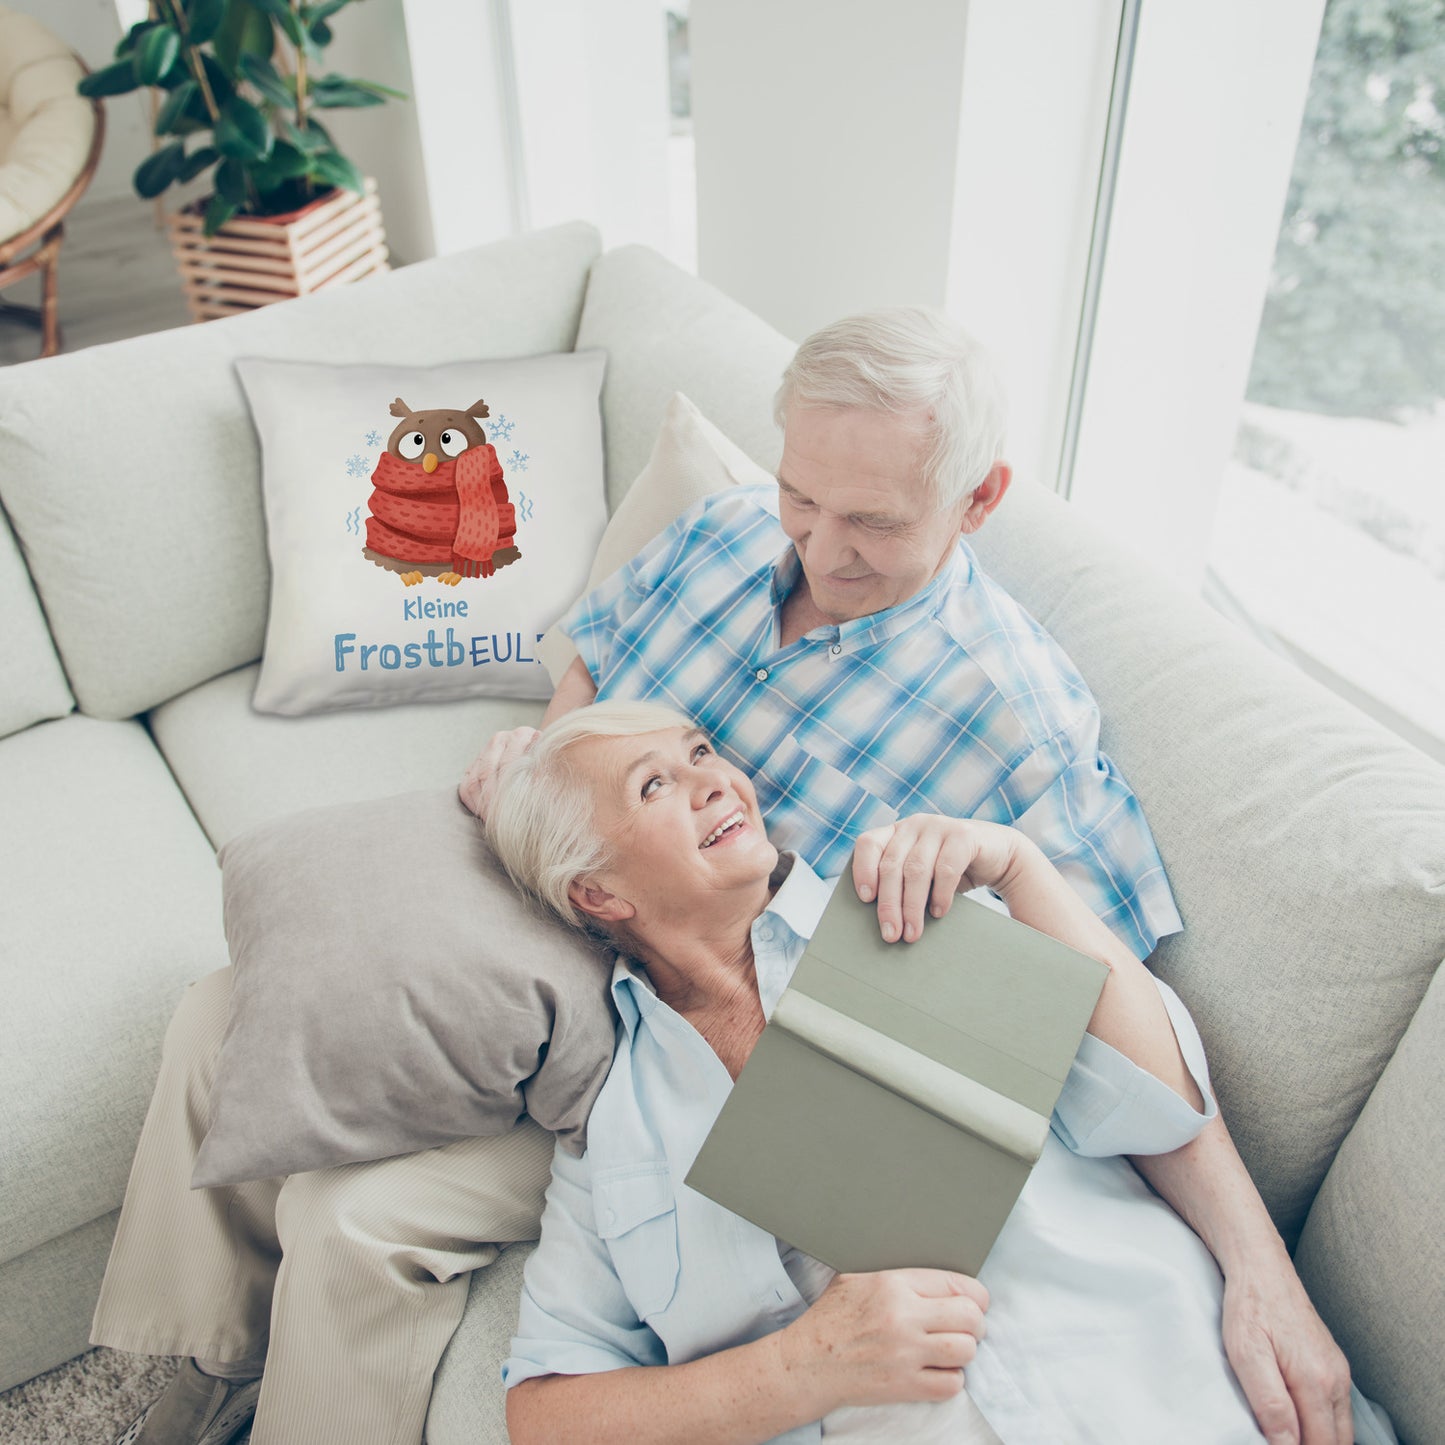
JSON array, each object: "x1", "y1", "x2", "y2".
[{"x1": 853, "y1": 814, "x2": 1205, "y2": 1111}]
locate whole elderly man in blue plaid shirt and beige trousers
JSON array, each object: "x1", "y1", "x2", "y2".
[{"x1": 92, "y1": 304, "x2": 1350, "y2": 1445}]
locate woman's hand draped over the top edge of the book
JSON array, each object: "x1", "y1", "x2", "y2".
[{"x1": 853, "y1": 814, "x2": 1035, "y2": 944}]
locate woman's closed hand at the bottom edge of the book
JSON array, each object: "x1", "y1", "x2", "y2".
[{"x1": 779, "y1": 1269, "x2": 988, "y2": 1413}]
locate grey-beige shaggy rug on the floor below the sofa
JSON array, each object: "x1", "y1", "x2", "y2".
[{"x1": 0, "y1": 1350, "x2": 250, "y2": 1445}]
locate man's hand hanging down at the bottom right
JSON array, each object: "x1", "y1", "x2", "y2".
[{"x1": 1224, "y1": 1259, "x2": 1354, "y2": 1445}]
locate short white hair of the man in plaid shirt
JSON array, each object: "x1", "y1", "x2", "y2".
[{"x1": 773, "y1": 306, "x2": 1006, "y2": 507}]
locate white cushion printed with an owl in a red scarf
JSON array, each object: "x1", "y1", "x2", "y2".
[{"x1": 236, "y1": 351, "x2": 607, "y2": 715}]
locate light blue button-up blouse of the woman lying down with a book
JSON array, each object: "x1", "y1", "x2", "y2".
[{"x1": 503, "y1": 855, "x2": 1260, "y2": 1445}]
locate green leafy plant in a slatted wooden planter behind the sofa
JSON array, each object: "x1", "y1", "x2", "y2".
[{"x1": 79, "y1": 0, "x2": 405, "y2": 319}]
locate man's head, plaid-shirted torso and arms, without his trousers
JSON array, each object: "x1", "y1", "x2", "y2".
[{"x1": 462, "y1": 311, "x2": 1350, "y2": 1445}]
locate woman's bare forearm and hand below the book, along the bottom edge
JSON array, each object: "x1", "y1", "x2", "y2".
[{"x1": 507, "y1": 1269, "x2": 988, "y2": 1445}]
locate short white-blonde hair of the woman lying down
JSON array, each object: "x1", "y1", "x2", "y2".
[{"x1": 487, "y1": 702, "x2": 694, "y2": 944}]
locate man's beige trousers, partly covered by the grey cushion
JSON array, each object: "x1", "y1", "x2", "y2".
[{"x1": 91, "y1": 968, "x2": 552, "y2": 1445}]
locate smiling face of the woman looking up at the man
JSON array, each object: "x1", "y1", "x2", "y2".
[{"x1": 569, "y1": 727, "x2": 777, "y2": 923}]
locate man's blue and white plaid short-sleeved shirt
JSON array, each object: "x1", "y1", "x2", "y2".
[{"x1": 561, "y1": 486, "x2": 1182, "y2": 958}]
